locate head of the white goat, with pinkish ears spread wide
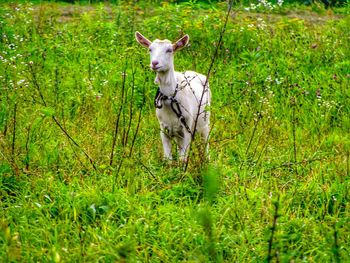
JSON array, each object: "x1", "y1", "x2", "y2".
[{"x1": 135, "y1": 32, "x2": 190, "y2": 72}]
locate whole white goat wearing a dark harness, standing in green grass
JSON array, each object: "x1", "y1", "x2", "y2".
[{"x1": 135, "y1": 32, "x2": 210, "y2": 161}]
